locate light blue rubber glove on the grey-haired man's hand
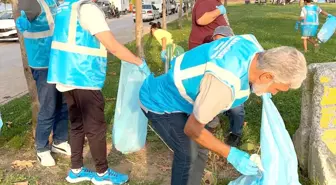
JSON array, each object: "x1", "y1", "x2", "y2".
[{"x1": 227, "y1": 147, "x2": 259, "y2": 175}]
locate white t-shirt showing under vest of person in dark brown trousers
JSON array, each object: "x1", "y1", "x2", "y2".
[{"x1": 56, "y1": 4, "x2": 110, "y2": 92}]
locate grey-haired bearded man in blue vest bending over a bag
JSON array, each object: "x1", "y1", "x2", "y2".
[{"x1": 140, "y1": 35, "x2": 307, "y2": 185}]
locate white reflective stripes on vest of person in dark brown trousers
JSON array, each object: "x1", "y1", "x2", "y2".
[{"x1": 51, "y1": 2, "x2": 107, "y2": 57}]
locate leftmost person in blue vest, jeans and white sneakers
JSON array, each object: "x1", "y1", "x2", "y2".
[{"x1": 16, "y1": 0, "x2": 71, "y2": 166}]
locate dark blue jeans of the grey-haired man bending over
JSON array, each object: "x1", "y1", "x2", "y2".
[{"x1": 145, "y1": 112, "x2": 200, "y2": 185}]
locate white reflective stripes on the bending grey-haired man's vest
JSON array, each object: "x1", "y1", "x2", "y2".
[{"x1": 173, "y1": 35, "x2": 263, "y2": 107}]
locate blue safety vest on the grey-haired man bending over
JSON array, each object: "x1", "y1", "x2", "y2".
[{"x1": 140, "y1": 35, "x2": 263, "y2": 114}]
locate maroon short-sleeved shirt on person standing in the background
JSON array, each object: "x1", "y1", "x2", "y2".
[{"x1": 189, "y1": 0, "x2": 227, "y2": 50}]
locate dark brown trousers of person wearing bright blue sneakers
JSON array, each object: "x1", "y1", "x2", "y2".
[{"x1": 64, "y1": 89, "x2": 108, "y2": 173}]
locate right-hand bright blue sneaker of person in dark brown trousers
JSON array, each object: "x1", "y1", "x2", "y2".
[{"x1": 92, "y1": 169, "x2": 128, "y2": 185}]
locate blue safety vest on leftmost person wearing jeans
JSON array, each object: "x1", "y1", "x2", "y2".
[{"x1": 23, "y1": 0, "x2": 57, "y2": 69}]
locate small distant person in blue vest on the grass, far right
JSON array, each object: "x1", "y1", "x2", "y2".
[{"x1": 295, "y1": 0, "x2": 331, "y2": 52}]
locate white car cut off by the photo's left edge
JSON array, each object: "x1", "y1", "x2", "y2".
[{"x1": 0, "y1": 10, "x2": 18, "y2": 41}]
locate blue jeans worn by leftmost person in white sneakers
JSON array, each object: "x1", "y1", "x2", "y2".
[{"x1": 31, "y1": 69, "x2": 68, "y2": 152}]
